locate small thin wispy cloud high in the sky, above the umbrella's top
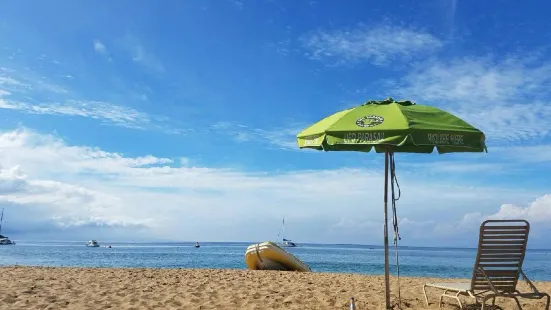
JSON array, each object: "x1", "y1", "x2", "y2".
[{"x1": 302, "y1": 25, "x2": 443, "y2": 65}]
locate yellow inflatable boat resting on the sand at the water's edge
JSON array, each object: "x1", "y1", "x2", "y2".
[{"x1": 245, "y1": 241, "x2": 312, "y2": 272}]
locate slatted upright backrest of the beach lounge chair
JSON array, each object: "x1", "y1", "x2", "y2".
[{"x1": 471, "y1": 220, "x2": 530, "y2": 292}]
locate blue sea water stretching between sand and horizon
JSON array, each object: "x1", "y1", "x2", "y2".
[{"x1": 0, "y1": 242, "x2": 551, "y2": 281}]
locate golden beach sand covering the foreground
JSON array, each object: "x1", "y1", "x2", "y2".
[{"x1": 0, "y1": 266, "x2": 551, "y2": 310}]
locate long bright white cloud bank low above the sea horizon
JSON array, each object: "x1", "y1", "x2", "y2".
[{"x1": 0, "y1": 130, "x2": 544, "y2": 243}]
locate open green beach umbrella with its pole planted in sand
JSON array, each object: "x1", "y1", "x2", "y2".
[{"x1": 297, "y1": 98, "x2": 486, "y2": 309}]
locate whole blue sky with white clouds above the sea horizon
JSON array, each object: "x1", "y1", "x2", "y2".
[{"x1": 0, "y1": 0, "x2": 551, "y2": 247}]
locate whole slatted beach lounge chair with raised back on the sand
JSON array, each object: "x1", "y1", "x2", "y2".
[{"x1": 423, "y1": 220, "x2": 550, "y2": 310}]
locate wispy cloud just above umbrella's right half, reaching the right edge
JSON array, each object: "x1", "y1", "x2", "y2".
[{"x1": 396, "y1": 56, "x2": 551, "y2": 103}]
